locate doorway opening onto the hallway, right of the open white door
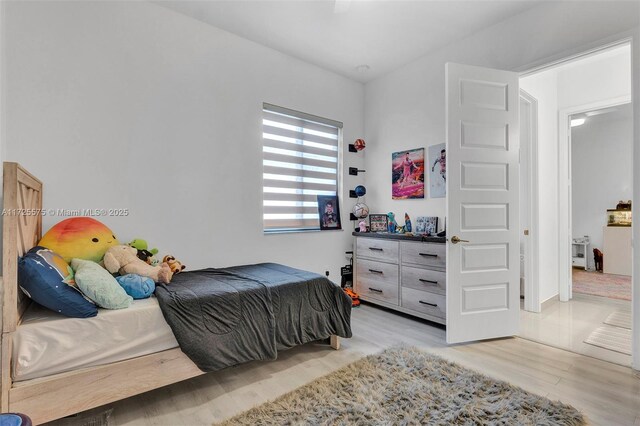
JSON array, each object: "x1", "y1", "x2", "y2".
[{"x1": 520, "y1": 43, "x2": 633, "y2": 365}]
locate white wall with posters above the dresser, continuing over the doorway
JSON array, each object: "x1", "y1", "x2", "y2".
[{"x1": 365, "y1": 2, "x2": 640, "y2": 245}]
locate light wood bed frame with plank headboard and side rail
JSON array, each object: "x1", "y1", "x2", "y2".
[{"x1": 0, "y1": 162, "x2": 340, "y2": 424}]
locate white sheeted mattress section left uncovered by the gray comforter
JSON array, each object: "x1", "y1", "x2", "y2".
[{"x1": 11, "y1": 296, "x2": 178, "y2": 381}]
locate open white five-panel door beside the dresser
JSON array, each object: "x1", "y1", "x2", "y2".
[{"x1": 446, "y1": 63, "x2": 520, "y2": 343}]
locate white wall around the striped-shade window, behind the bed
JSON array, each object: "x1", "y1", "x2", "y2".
[{"x1": 6, "y1": 2, "x2": 363, "y2": 281}]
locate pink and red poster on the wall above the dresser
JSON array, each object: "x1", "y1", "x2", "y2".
[{"x1": 391, "y1": 148, "x2": 424, "y2": 200}]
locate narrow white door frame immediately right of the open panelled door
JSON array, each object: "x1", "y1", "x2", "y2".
[{"x1": 520, "y1": 89, "x2": 542, "y2": 312}]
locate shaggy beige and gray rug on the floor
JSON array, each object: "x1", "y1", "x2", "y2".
[{"x1": 223, "y1": 347, "x2": 585, "y2": 426}]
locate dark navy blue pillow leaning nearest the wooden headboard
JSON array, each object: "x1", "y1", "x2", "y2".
[{"x1": 18, "y1": 247, "x2": 98, "y2": 318}]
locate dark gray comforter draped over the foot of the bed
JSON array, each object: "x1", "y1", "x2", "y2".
[{"x1": 156, "y1": 263, "x2": 351, "y2": 371}]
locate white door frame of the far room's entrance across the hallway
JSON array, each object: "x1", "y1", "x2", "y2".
[{"x1": 558, "y1": 95, "x2": 633, "y2": 302}]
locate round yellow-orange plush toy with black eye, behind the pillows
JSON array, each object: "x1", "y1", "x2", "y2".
[{"x1": 38, "y1": 217, "x2": 120, "y2": 262}]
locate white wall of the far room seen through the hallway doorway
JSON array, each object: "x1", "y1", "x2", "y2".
[{"x1": 571, "y1": 115, "x2": 633, "y2": 267}]
